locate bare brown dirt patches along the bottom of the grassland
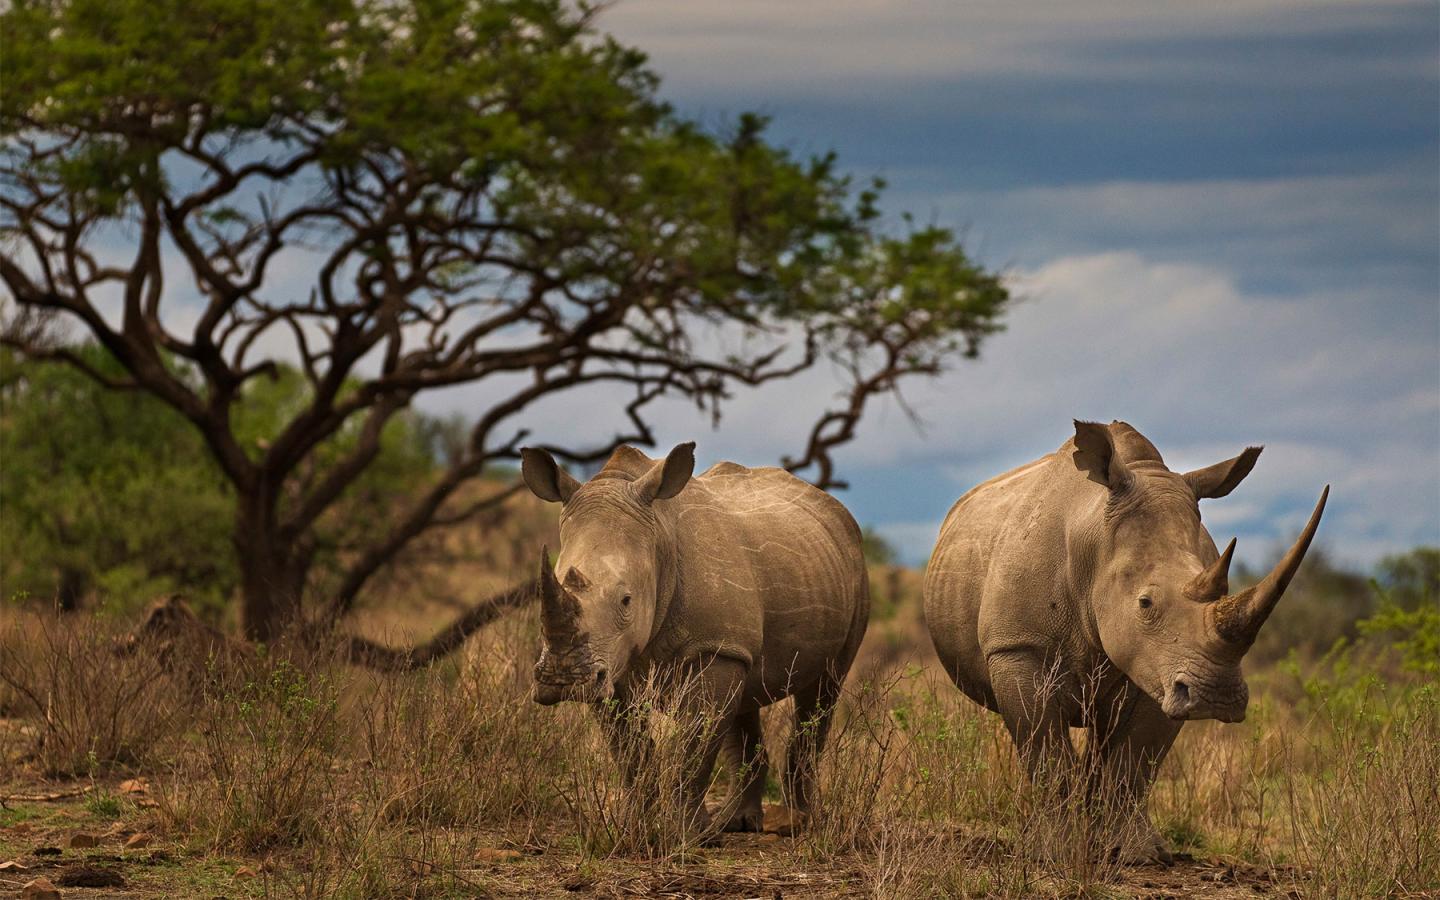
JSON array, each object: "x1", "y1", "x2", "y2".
[{"x1": 0, "y1": 779, "x2": 1302, "y2": 900}]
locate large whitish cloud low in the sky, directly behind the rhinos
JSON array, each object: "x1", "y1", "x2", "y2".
[{"x1": 414, "y1": 252, "x2": 1440, "y2": 564}]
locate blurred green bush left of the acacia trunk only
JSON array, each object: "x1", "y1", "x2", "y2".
[{"x1": 0, "y1": 346, "x2": 236, "y2": 606}]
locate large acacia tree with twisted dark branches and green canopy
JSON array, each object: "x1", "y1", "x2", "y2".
[{"x1": 0, "y1": 0, "x2": 1008, "y2": 639}]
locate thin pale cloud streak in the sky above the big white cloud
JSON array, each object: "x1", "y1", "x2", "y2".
[{"x1": 891, "y1": 161, "x2": 1440, "y2": 288}]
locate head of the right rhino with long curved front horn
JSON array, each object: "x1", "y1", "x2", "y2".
[{"x1": 1074, "y1": 422, "x2": 1329, "y2": 721}]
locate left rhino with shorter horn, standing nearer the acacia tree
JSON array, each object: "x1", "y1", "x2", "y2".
[{"x1": 521, "y1": 444, "x2": 870, "y2": 831}]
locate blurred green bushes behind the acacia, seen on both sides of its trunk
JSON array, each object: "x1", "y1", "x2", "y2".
[{"x1": 0, "y1": 346, "x2": 436, "y2": 613}]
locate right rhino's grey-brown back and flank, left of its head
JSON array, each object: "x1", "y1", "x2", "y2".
[{"x1": 924, "y1": 445, "x2": 1089, "y2": 708}]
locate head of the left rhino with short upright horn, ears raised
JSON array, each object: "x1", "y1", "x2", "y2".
[{"x1": 521, "y1": 444, "x2": 696, "y2": 706}]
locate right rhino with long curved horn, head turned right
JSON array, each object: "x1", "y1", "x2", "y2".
[{"x1": 924, "y1": 422, "x2": 1329, "y2": 861}]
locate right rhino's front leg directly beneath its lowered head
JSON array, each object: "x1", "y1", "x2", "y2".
[{"x1": 1087, "y1": 687, "x2": 1184, "y2": 864}]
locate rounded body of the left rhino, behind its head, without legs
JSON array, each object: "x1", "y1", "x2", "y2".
[{"x1": 658, "y1": 464, "x2": 870, "y2": 700}]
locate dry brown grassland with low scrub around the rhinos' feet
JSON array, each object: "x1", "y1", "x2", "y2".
[{"x1": 0, "y1": 498, "x2": 1440, "y2": 897}]
